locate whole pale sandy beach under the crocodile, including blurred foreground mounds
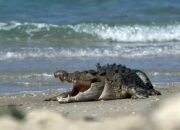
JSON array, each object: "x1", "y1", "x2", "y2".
[{"x1": 0, "y1": 86, "x2": 180, "y2": 130}]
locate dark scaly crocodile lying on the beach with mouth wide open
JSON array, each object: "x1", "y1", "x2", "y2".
[{"x1": 45, "y1": 63, "x2": 161, "y2": 103}]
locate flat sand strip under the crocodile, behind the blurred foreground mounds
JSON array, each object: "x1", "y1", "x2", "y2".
[{"x1": 0, "y1": 86, "x2": 180, "y2": 120}]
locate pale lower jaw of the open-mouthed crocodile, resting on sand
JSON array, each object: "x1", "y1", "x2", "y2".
[{"x1": 57, "y1": 82, "x2": 104, "y2": 103}]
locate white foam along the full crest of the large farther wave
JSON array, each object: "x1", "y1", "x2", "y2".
[{"x1": 0, "y1": 21, "x2": 180, "y2": 42}]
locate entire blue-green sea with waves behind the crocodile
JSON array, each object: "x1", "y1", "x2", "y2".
[{"x1": 0, "y1": 0, "x2": 180, "y2": 94}]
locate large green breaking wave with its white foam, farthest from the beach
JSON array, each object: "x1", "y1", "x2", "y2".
[{"x1": 0, "y1": 22, "x2": 180, "y2": 44}]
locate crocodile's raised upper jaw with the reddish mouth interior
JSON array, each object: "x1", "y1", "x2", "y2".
[{"x1": 54, "y1": 70, "x2": 101, "y2": 96}]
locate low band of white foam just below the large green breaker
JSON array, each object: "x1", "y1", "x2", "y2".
[{"x1": 0, "y1": 44, "x2": 180, "y2": 60}]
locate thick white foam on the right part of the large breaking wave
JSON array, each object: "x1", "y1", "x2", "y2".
[{"x1": 70, "y1": 24, "x2": 180, "y2": 42}]
